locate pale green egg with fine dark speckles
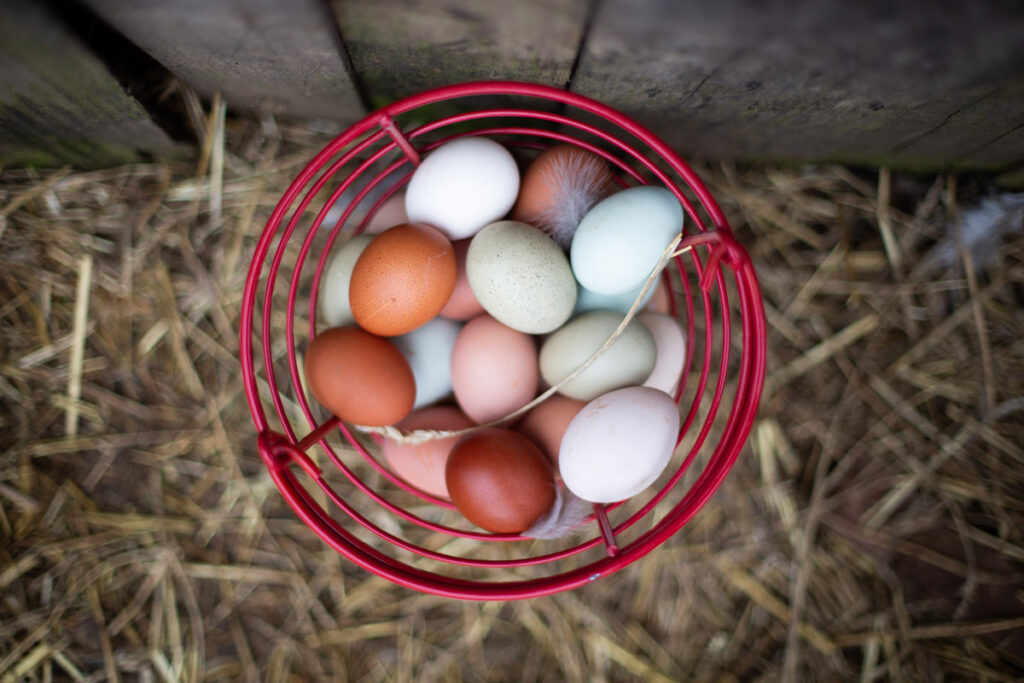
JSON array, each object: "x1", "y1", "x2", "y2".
[{"x1": 466, "y1": 220, "x2": 577, "y2": 335}]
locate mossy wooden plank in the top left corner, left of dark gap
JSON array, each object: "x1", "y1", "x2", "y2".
[{"x1": 0, "y1": 0, "x2": 177, "y2": 168}]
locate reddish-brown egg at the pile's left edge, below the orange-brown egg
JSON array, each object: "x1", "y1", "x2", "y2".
[{"x1": 305, "y1": 326, "x2": 416, "y2": 427}]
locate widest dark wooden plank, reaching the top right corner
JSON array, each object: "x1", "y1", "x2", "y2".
[{"x1": 574, "y1": 0, "x2": 1024, "y2": 168}]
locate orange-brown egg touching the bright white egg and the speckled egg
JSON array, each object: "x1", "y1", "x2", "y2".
[{"x1": 348, "y1": 223, "x2": 456, "y2": 337}]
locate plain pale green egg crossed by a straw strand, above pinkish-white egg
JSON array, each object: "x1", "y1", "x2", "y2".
[{"x1": 540, "y1": 310, "x2": 656, "y2": 400}]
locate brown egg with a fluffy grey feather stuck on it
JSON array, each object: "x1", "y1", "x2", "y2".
[{"x1": 512, "y1": 144, "x2": 613, "y2": 249}]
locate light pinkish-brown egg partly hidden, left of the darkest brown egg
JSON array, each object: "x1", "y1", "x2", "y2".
[{"x1": 381, "y1": 405, "x2": 473, "y2": 499}]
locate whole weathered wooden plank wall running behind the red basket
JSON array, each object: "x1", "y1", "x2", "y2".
[{"x1": 0, "y1": 0, "x2": 1024, "y2": 170}]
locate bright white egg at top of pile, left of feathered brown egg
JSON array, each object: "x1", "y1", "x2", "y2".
[{"x1": 406, "y1": 137, "x2": 519, "y2": 240}]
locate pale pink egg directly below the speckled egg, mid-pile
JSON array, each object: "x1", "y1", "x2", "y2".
[{"x1": 452, "y1": 314, "x2": 540, "y2": 424}]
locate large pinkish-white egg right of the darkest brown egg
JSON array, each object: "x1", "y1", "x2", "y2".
[{"x1": 558, "y1": 387, "x2": 679, "y2": 503}]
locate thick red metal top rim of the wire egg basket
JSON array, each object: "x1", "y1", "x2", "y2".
[{"x1": 240, "y1": 81, "x2": 766, "y2": 600}]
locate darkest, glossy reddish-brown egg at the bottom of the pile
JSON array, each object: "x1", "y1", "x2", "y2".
[{"x1": 444, "y1": 427, "x2": 555, "y2": 533}]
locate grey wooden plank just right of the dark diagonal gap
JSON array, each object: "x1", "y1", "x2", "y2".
[{"x1": 85, "y1": 0, "x2": 364, "y2": 123}]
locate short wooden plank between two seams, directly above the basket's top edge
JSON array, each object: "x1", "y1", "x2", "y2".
[{"x1": 333, "y1": 0, "x2": 588, "y2": 106}]
